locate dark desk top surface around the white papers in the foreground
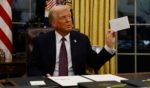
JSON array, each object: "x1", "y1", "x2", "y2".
[{"x1": 1, "y1": 73, "x2": 150, "y2": 88}]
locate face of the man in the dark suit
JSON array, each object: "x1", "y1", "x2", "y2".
[{"x1": 54, "y1": 10, "x2": 73, "y2": 34}]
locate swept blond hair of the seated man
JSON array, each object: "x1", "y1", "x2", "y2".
[{"x1": 48, "y1": 5, "x2": 71, "y2": 24}]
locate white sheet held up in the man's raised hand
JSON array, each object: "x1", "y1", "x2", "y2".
[{"x1": 110, "y1": 16, "x2": 130, "y2": 31}]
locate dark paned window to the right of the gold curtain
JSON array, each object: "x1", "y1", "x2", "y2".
[{"x1": 117, "y1": 0, "x2": 150, "y2": 73}]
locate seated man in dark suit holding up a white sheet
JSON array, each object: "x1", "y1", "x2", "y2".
[{"x1": 27, "y1": 5, "x2": 115, "y2": 76}]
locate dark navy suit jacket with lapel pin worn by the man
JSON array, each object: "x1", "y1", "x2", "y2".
[{"x1": 27, "y1": 30, "x2": 113, "y2": 76}]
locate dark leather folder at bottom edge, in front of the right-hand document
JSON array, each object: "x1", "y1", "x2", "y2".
[{"x1": 78, "y1": 81, "x2": 134, "y2": 88}]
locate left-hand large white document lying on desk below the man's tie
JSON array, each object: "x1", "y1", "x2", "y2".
[{"x1": 48, "y1": 76, "x2": 92, "y2": 86}]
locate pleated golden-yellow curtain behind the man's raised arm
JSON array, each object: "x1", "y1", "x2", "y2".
[{"x1": 72, "y1": 0, "x2": 116, "y2": 74}]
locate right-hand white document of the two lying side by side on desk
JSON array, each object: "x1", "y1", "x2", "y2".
[{"x1": 83, "y1": 74, "x2": 127, "y2": 82}]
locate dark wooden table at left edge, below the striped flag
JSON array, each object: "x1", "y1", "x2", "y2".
[{"x1": 0, "y1": 59, "x2": 26, "y2": 79}]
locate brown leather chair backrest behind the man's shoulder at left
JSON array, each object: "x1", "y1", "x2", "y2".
[{"x1": 26, "y1": 28, "x2": 53, "y2": 57}]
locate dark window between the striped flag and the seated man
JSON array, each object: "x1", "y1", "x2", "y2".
[{"x1": 12, "y1": 0, "x2": 36, "y2": 54}]
